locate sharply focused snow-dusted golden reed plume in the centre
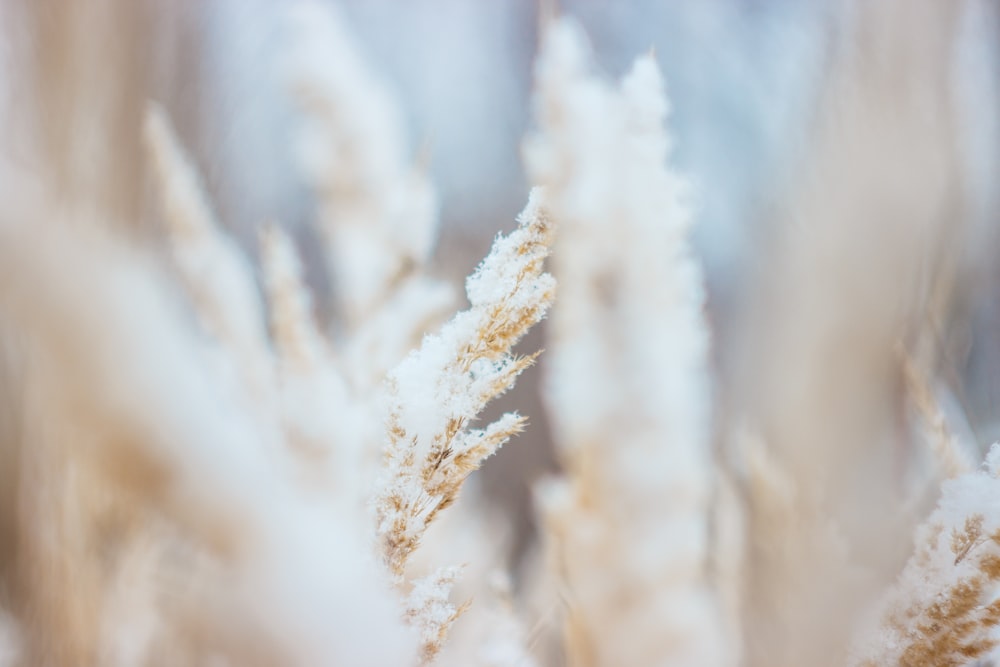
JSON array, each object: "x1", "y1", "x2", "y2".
[{"x1": 375, "y1": 193, "x2": 555, "y2": 657}]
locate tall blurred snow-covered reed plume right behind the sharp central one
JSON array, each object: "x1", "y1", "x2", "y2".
[{"x1": 525, "y1": 22, "x2": 728, "y2": 666}]
